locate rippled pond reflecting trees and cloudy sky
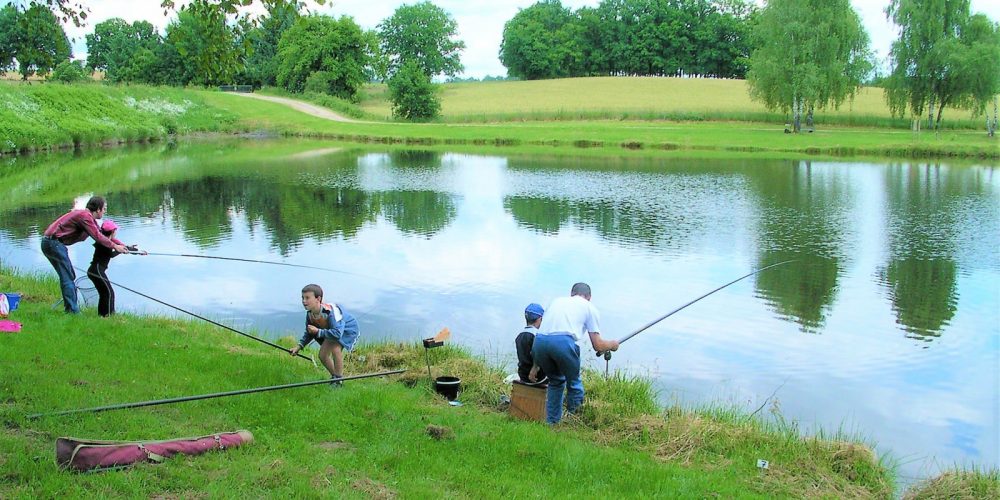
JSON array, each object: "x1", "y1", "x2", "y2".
[{"x1": 0, "y1": 140, "x2": 1000, "y2": 482}]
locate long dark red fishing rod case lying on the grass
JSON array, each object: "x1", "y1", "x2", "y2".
[{"x1": 56, "y1": 430, "x2": 253, "y2": 472}]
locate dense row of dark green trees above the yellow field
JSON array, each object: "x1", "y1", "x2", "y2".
[{"x1": 500, "y1": 0, "x2": 757, "y2": 80}]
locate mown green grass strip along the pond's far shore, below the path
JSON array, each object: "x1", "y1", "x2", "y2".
[{"x1": 201, "y1": 89, "x2": 1000, "y2": 159}]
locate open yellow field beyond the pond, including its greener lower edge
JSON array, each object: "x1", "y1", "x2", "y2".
[{"x1": 360, "y1": 77, "x2": 983, "y2": 128}]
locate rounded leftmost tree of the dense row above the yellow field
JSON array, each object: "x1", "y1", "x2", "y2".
[{"x1": 500, "y1": 0, "x2": 586, "y2": 80}]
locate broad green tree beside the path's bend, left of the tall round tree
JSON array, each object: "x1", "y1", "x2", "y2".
[{"x1": 276, "y1": 15, "x2": 368, "y2": 99}]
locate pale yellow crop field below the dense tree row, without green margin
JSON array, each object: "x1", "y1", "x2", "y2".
[{"x1": 361, "y1": 77, "x2": 900, "y2": 119}]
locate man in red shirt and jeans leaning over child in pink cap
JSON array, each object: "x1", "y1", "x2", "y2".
[{"x1": 42, "y1": 196, "x2": 128, "y2": 314}]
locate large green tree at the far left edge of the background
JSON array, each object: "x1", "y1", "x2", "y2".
[{"x1": 0, "y1": 4, "x2": 73, "y2": 80}]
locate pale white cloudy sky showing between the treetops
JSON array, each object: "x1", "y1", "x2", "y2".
[{"x1": 29, "y1": 0, "x2": 1000, "y2": 78}]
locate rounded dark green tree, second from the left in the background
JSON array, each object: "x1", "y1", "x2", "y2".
[{"x1": 86, "y1": 17, "x2": 162, "y2": 82}]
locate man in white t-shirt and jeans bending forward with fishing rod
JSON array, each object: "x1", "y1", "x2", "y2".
[{"x1": 531, "y1": 283, "x2": 618, "y2": 424}]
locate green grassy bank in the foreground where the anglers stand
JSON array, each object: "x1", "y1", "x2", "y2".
[{"x1": 0, "y1": 269, "x2": 904, "y2": 498}]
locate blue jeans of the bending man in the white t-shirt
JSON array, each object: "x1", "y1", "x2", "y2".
[{"x1": 531, "y1": 334, "x2": 583, "y2": 424}]
